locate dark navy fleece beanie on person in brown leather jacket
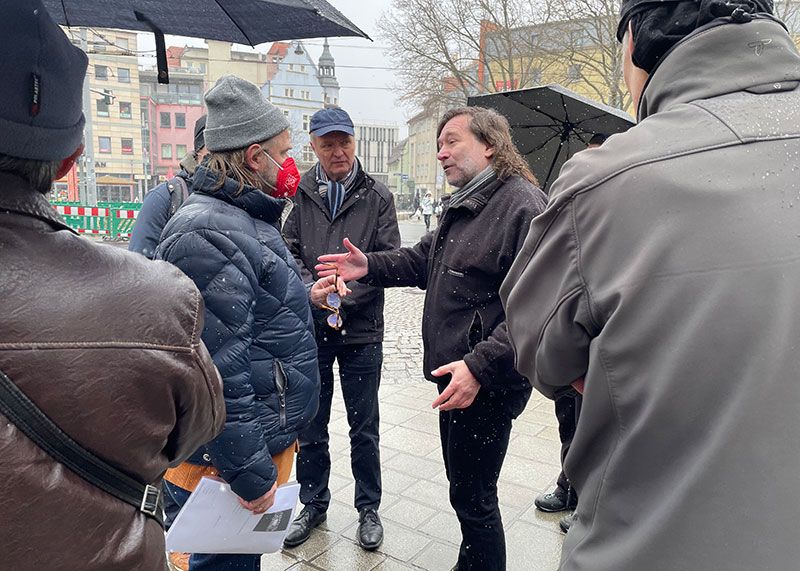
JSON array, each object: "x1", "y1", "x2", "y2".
[{"x1": 0, "y1": 0, "x2": 88, "y2": 161}]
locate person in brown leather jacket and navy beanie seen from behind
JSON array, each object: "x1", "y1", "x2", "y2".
[{"x1": 0, "y1": 0, "x2": 225, "y2": 571}]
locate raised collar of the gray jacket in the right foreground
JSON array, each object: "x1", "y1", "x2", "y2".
[{"x1": 638, "y1": 15, "x2": 800, "y2": 121}]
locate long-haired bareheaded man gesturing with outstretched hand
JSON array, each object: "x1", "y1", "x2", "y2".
[{"x1": 317, "y1": 107, "x2": 545, "y2": 571}]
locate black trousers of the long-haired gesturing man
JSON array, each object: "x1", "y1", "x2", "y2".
[{"x1": 438, "y1": 383, "x2": 530, "y2": 571}]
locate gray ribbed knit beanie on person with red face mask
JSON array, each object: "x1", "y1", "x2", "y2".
[{"x1": 204, "y1": 75, "x2": 289, "y2": 152}]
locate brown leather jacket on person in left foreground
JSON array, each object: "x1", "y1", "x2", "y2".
[{"x1": 0, "y1": 173, "x2": 225, "y2": 571}]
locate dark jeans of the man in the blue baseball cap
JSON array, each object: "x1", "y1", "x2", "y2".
[{"x1": 297, "y1": 343, "x2": 383, "y2": 512}]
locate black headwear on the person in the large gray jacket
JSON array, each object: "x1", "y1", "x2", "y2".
[{"x1": 617, "y1": 0, "x2": 773, "y2": 73}]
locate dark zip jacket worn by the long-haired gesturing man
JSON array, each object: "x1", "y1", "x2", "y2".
[{"x1": 362, "y1": 176, "x2": 546, "y2": 389}]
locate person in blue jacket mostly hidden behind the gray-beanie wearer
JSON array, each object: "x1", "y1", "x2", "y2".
[{"x1": 128, "y1": 115, "x2": 208, "y2": 259}]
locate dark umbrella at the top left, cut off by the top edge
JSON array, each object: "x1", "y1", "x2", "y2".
[{"x1": 43, "y1": 0, "x2": 369, "y2": 83}]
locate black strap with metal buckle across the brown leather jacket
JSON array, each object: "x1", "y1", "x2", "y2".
[{"x1": 0, "y1": 371, "x2": 164, "y2": 527}]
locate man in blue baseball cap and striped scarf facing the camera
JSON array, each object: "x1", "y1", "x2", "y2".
[{"x1": 284, "y1": 107, "x2": 400, "y2": 550}]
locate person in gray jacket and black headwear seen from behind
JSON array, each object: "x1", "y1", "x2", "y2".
[{"x1": 501, "y1": 0, "x2": 800, "y2": 571}]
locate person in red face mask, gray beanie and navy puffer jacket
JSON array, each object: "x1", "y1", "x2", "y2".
[{"x1": 156, "y1": 76, "x2": 347, "y2": 571}]
